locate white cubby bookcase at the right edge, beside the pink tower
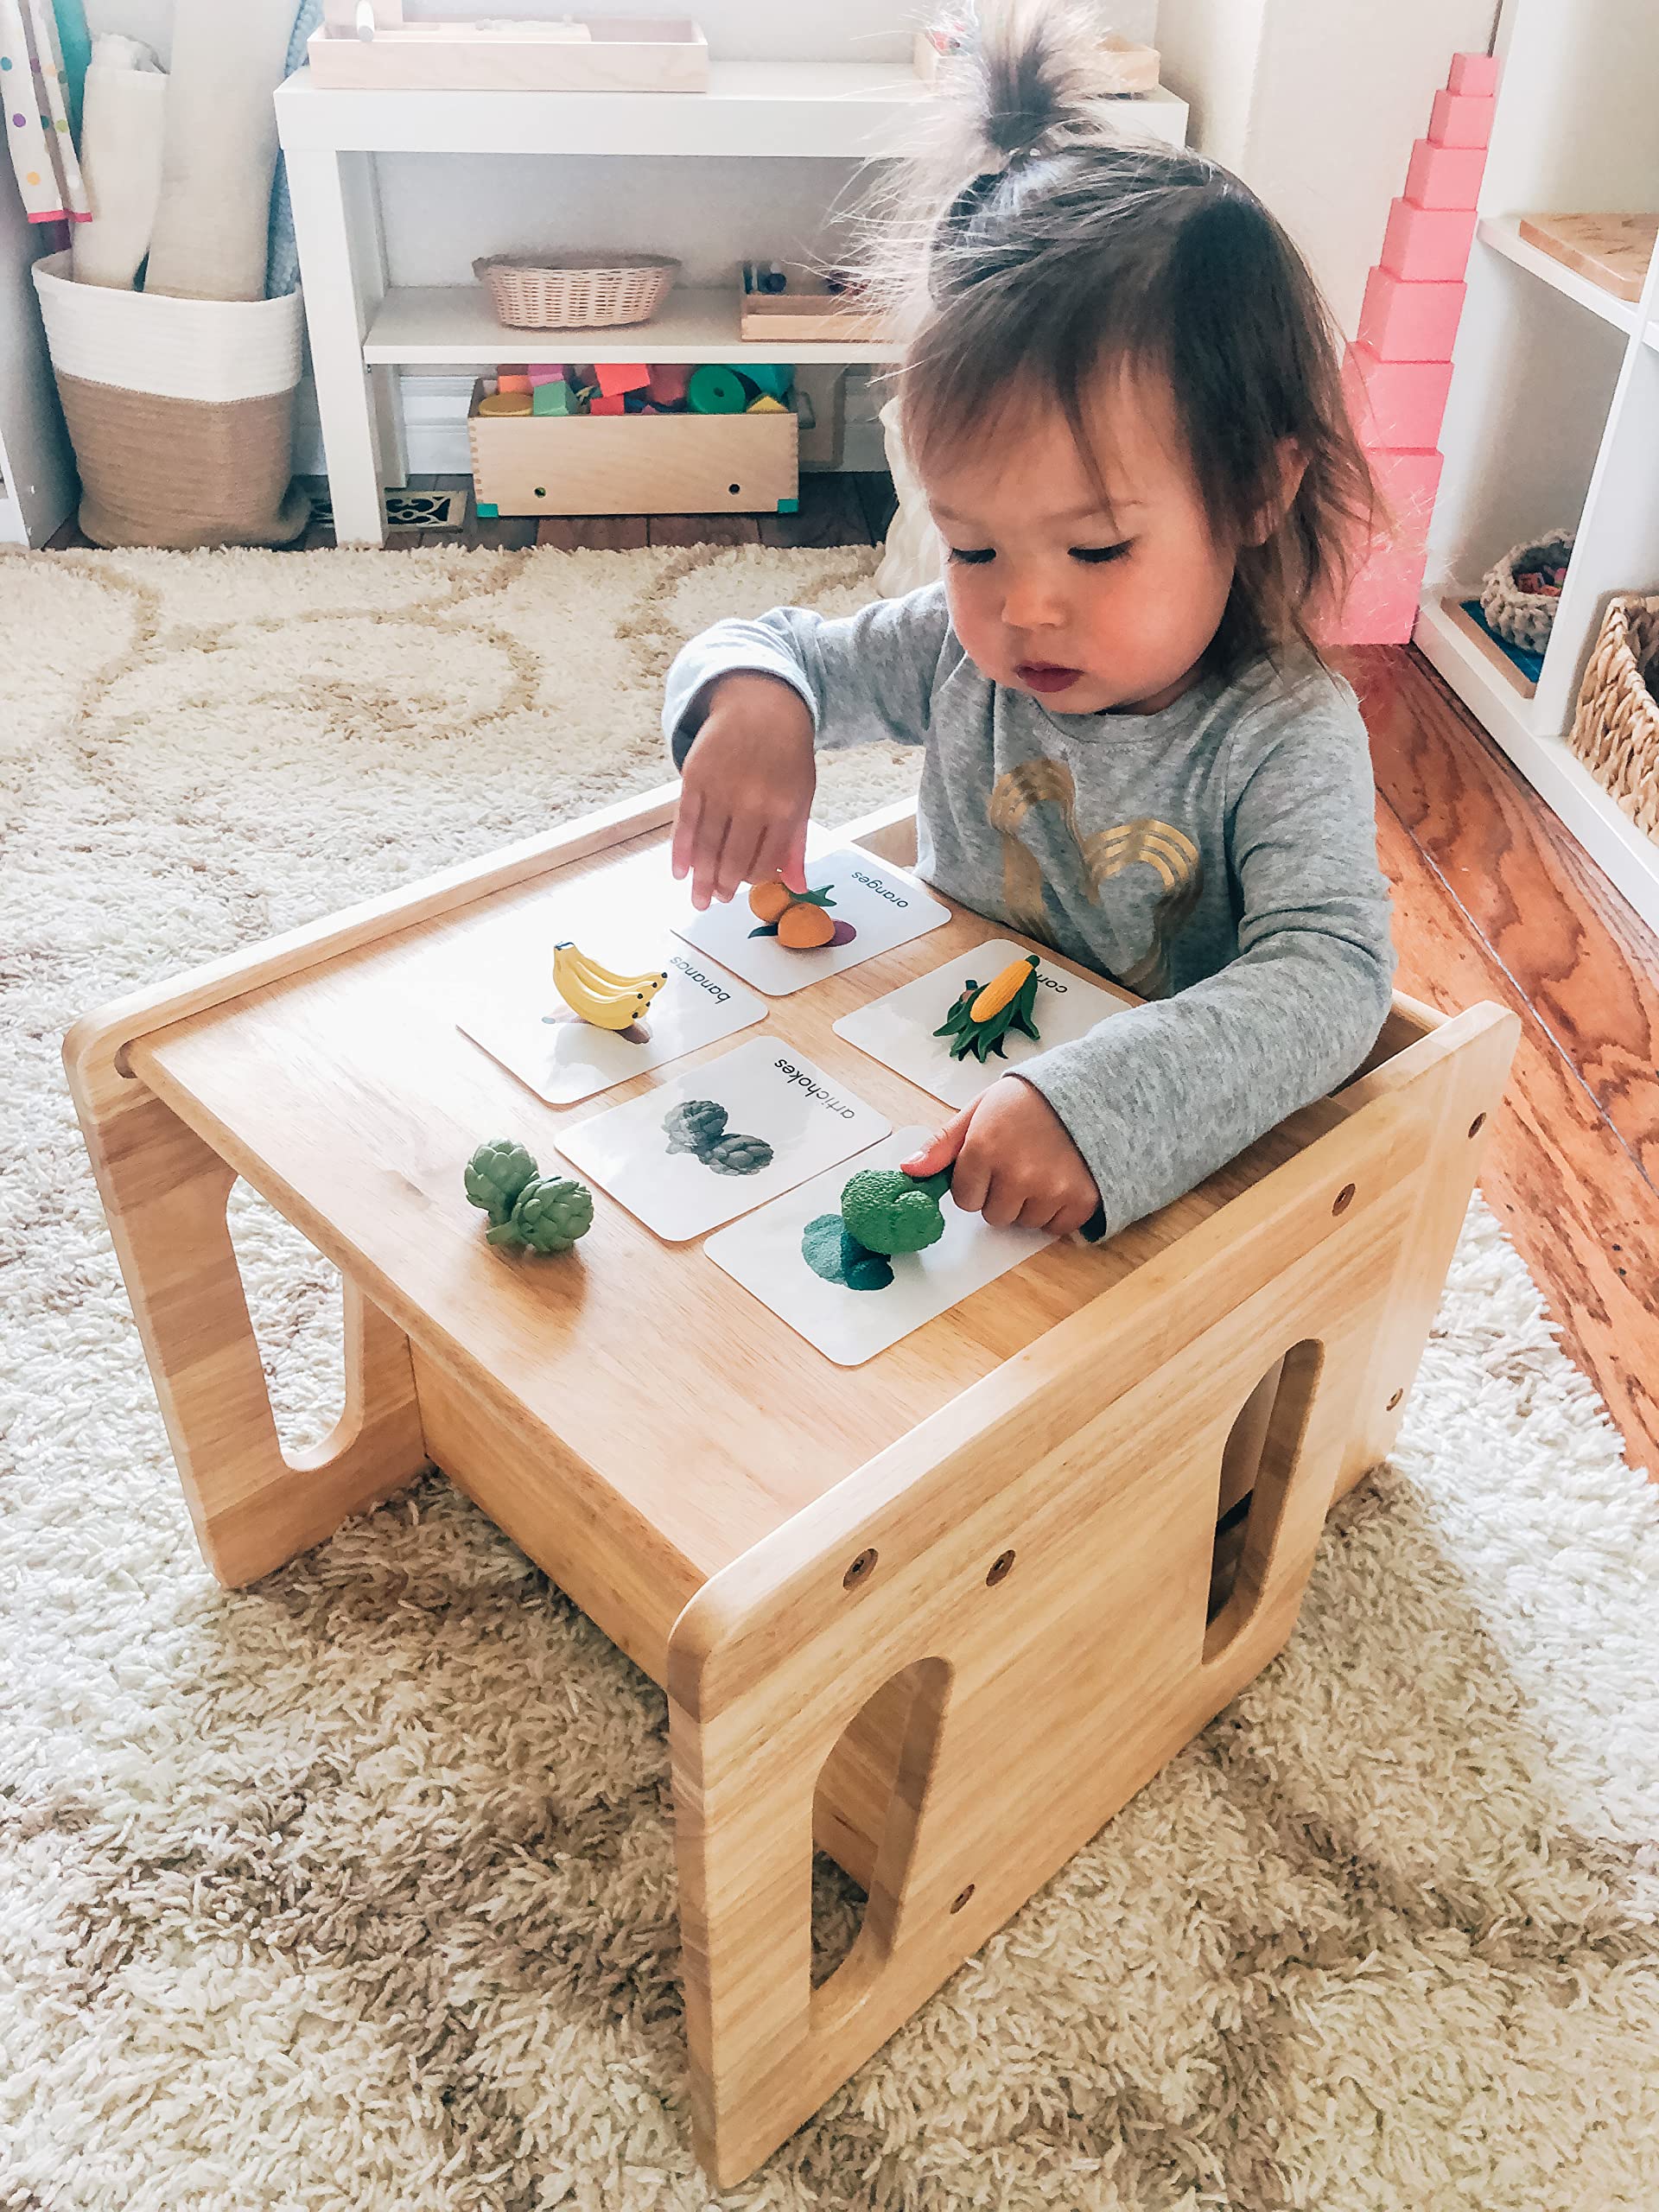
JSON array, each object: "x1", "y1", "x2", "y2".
[{"x1": 1414, "y1": 0, "x2": 1659, "y2": 929}]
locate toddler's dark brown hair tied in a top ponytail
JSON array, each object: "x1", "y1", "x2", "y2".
[{"x1": 872, "y1": 0, "x2": 1380, "y2": 671}]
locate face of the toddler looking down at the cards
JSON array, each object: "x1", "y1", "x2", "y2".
[{"x1": 925, "y1": 378, "x2": 1232, "y2": 715}]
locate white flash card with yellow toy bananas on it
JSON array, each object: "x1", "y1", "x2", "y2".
[{"x1": 460, "y1": 931, "x2": 766, "y2": 1106}]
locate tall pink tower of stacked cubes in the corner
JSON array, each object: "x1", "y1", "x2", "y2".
[{"x1": 1320, "y1": 53, "x2": 1497, "y2": 646}]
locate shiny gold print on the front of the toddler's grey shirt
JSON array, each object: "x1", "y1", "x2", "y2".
[{"x1": 987, "y1": 761, "x2": 1204, "y2": 998}]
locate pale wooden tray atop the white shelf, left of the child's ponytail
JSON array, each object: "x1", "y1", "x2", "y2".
[{"x1": 305, "y1": 0, "x2": 708, "y2": 93}]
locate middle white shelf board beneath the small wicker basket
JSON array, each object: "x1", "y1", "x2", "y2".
[{"x1": 363, "y1": 285, "x2": 893, "y2": 367}]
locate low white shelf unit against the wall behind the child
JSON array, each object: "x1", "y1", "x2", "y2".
[{"x1": 276, "y1": 60, "x2": 1185, "y2": 544}]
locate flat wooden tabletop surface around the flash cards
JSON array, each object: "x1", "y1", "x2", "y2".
[{"x1": 133, "y1": 832, "x2": 1294, "y2": 1575}]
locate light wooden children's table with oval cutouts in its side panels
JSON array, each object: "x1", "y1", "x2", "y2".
[{"x1": 64, "y1": 785, "x2": 1517, "y2": 2185}]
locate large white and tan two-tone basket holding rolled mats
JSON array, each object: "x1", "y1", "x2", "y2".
[{"x1": 33, "y1": 252, "x2": 309, "y2": 546}]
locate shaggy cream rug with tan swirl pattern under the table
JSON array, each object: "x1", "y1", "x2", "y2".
[{"x1": 0, "y1": 550, "x2": 1659, "y2": 2212}]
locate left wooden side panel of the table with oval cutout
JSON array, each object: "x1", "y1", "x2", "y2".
[{"x1": 71, "y1": 1064, "x2": 425, "y2": 1584}]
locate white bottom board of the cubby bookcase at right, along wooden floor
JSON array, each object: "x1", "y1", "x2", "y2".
[{"x1": 1414, "y1": 600, "x2": 1659, "y2": 929}]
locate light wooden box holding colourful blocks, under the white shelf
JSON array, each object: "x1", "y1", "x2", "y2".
[{"x1": 467, "y1": 378, "x2": 801, "y2": 515}]
